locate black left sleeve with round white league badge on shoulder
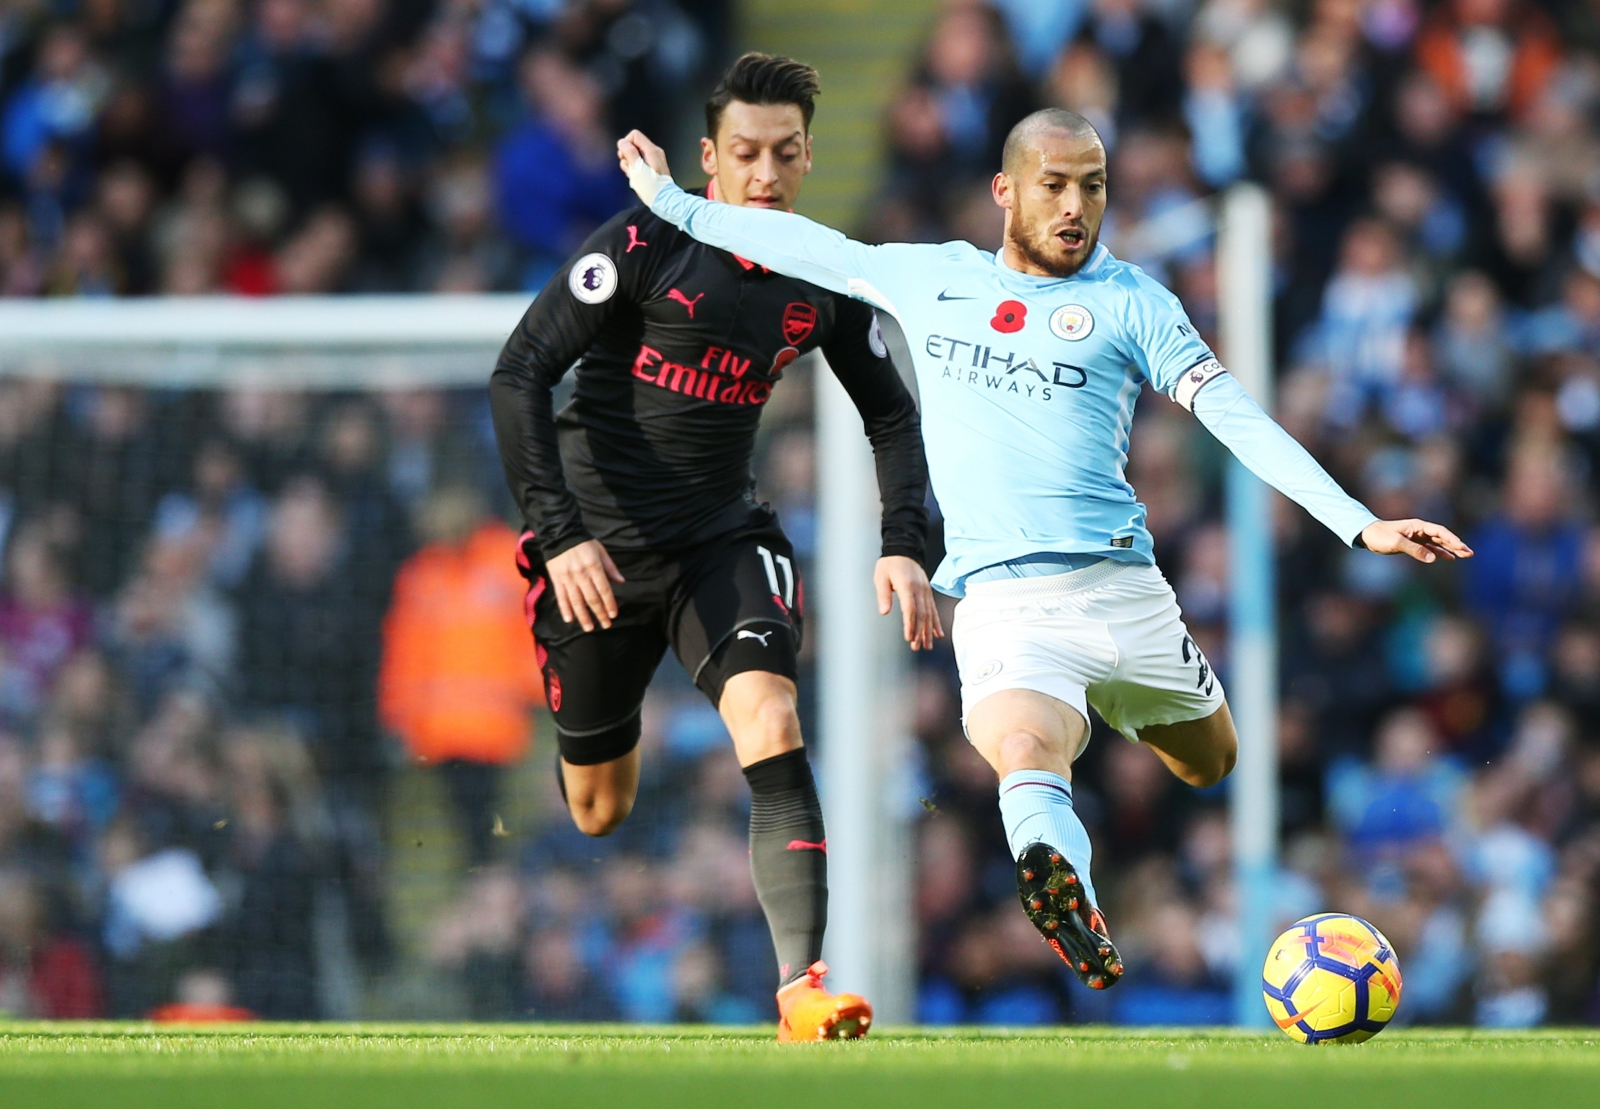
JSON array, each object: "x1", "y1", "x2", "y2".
[{"x1": 490, "y1": 210, "x2": 659, "y2": 559}]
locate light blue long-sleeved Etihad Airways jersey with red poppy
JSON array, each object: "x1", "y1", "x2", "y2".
[{"x1": 651, "y1": 184, "x2": 1374, "y2": 595}]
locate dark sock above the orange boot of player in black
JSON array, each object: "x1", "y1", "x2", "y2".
[{"x1": 744, "y1": 747, "x2": 827, "y2": 986}]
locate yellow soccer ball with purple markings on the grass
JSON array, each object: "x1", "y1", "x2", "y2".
[{"x1": 1261, "y1": 912, "x2": 1400, "y2": 1043}]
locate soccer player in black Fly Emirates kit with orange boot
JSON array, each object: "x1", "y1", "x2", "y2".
[{"x1": 490, "y1": 54, "x2": 944, "y2": 1040}]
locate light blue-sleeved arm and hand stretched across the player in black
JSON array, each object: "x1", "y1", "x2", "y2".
[{"x1": 616, "y1": 131, "x2": 890, "y2": 307}]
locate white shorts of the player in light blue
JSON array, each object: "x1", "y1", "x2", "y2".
[{"x1": 950, "y1": 560, "x2": 1222, "y2": 739}]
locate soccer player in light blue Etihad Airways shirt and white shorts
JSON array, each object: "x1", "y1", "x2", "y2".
[{"x1": 618, "y1": 109, "x2": 1472, "y2": 989}]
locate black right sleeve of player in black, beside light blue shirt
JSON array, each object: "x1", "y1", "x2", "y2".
[{"x1": 822, "y1": 299, "x2": 928, "y2": 562}]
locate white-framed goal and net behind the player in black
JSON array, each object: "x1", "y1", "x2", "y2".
[{"x1": 0, "y1": 296, "x2": 910, "y2": 1023}]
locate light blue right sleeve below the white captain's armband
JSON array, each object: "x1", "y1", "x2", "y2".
[{"x1": 1189, "y1": 373, "x2": 1378, "y2": 546}]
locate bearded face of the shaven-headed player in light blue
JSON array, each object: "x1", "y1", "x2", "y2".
[{"x1": 994, "y1": 131, "x2": 1106, "y2": 277}]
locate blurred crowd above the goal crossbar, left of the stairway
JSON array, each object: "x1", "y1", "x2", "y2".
[{"x1": 0, "y1": 0, "x2": 730, "y2": 296}]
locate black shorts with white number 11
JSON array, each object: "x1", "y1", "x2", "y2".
[{"x1": 517, "y1": 518, "x2": 805, "y2": 767}]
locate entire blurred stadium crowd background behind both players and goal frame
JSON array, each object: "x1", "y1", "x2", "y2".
[{"x1": 0, "y1": 0, "x2": 1600, "y2": 1026}]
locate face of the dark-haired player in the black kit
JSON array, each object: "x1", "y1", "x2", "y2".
[{"x1": 701, "y1": 101, "x2": 811, "y2": 210}]
